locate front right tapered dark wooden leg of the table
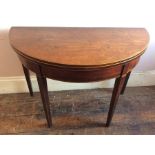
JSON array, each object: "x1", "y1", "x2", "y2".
[{"x1": 106, "y1": 76, "x2": 125, "y2": 127}]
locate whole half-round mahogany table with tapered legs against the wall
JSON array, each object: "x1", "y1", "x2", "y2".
[{"x1": 9, "y1": 27, "x2": 149, "y2": 127}]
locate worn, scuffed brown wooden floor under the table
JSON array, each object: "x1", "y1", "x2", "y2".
[{"x1": 0, "y1": 86, "x2": 155, "y2": 135}]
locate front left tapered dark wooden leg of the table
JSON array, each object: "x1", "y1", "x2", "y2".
[{"x1": 37, "y1": 75, "x2": 52, "y2": 128}]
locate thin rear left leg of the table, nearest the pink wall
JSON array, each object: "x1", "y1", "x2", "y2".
[{"x1": 22, "y1": 65, "x2": 33, "y2": 96}]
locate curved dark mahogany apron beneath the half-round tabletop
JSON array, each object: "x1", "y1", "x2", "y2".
[{"x1": 18, "y1": 55, "x2": 139, "y2": 82}]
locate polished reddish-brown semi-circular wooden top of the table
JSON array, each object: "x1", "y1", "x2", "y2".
[{"x1": 9, "y1": 27, "x2": 149, "y2": 67}]
